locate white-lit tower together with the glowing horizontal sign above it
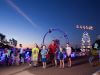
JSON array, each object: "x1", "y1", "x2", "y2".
[{"x1": 76, "y1": 25, "x2": 94, "y2": 50}]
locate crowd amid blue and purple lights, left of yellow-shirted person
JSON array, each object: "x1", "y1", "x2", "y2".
[{"x1": 0, "y1": 44, "x2": 31, "y2": 65}]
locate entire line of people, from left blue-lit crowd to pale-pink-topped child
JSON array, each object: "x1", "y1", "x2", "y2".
[{"x1": 0, "y1": 41, "x2": 71, "y2": 69}]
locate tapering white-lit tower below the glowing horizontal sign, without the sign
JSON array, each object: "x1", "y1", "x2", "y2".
[{"x1": 81, "y1": 32, "x2": 91, "y2": 49}]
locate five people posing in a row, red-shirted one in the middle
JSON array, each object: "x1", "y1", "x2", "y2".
[{"x1": 32, "y1": 43, "x2": 72, "y2": 69}]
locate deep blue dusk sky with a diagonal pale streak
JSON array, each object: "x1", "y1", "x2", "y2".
[{"x1": 0, "y1": 0, "x2": 100, "y2": 45}]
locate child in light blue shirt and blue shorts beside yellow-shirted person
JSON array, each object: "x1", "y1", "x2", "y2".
[{"x1": 41, "y1": 45, "x2": 48, "y2": 69}]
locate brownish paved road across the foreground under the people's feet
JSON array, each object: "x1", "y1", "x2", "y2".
[{"x1": 0, "y1": 56, "x2": 100, "y2": 75}]
